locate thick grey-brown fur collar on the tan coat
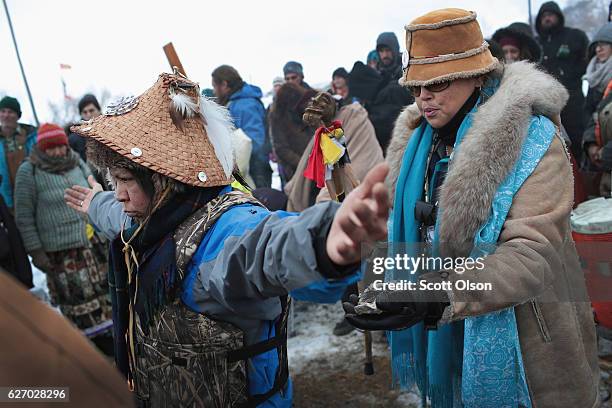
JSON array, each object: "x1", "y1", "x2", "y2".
[{"x1": 387, "y1": 62, "x2": 568, "y2": 256}]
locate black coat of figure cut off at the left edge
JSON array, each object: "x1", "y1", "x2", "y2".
[{"x1": 0, "y1": 195, "x2": 34, "y2": 289}]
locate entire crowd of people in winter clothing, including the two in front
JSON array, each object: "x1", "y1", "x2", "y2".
[{"x1": 0, "y1": 1, "x2": 612, "y2": 407}]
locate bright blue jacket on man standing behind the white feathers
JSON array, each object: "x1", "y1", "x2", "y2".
[{"x1": 228, "y1": 82, "x2": 267, "y2": 157}]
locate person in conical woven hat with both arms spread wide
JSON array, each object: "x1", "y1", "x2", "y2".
[{"x1": 66, "y1": 74, "x2": 389, "y2": 407}]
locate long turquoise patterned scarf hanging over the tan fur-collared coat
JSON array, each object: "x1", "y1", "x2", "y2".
[{"x1": 386, "y1": 84, "x2": 556, "y2": 408}]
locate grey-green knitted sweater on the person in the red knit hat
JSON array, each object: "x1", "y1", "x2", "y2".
[{"x1": 15, "y1": 150, "x2": 91, "y2": 253}]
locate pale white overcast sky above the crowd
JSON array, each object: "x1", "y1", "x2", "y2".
[{"x1": 0, "y1": 0, "x2": 567, "y2": 123}]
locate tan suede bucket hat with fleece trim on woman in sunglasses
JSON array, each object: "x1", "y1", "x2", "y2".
[{"x1": 400, "y1": 8, "x2": 499, "y2": 86}]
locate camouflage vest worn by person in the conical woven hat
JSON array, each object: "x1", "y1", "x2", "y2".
[{"x1": 134, "y1": 191, "x2": 261, "y2": 408}]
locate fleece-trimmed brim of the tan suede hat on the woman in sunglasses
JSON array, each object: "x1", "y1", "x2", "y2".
[{"x1": 399, "y1": 50, "x2": 500, "y2": 86}]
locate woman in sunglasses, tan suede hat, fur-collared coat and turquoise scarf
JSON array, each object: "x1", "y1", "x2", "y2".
[{"x1": 344, "y1": 9, "x2": 599, "y2": 408}]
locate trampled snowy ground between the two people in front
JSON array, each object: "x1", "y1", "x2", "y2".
[{"x1": 287, "y1": 302, "x2": 420, "y2": 408}]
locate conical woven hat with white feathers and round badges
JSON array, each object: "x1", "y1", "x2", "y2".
[{"x1": 71, "y1": 74, "x2": 234, "y2": 187}]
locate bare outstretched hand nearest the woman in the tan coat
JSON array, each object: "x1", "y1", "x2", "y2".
[{"x1": 326, "y1": 163, "x2": 391, "y2": 265}]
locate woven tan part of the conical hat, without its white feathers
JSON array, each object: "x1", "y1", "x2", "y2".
[{"x1": 71, "y1": 78, "x2": 232, "y2": 187}]
